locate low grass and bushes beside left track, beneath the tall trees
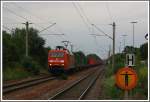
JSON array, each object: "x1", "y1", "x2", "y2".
[{"x1": 3, "y1": 58, "x2": 48, "y2": 81}]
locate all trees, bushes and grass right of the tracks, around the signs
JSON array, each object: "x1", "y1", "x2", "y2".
[{"x1": 102, "y1": 43, "x2": 148, "y2": 99}]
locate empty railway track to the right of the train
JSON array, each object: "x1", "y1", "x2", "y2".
[{"x1": 48, "y1": 68, "x2": 104, "y2": 100}]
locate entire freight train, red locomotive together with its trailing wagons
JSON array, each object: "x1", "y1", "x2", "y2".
[{"x1": 48, "y1": 46, "x2": 102, "y2": 73}]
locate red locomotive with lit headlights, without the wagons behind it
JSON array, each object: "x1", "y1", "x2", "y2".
[{"x1": 48, "y1": 46, "x2": 75, "y2": 73}]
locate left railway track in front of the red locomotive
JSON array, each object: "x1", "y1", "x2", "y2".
[{"x1": 2, "y1": 76, "x2": 56, "y2": 94}]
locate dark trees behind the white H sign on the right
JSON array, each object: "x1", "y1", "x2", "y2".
[{"x1": 108, "y1": 42, "x2": 148, "y2": 72}]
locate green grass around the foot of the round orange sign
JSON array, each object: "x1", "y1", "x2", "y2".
[{"x1": 103, "y1": 66, "x2": 148, "y2": 99}]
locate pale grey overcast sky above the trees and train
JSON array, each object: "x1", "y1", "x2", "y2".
[{"x1": 2, "y1": 2, "x2": 148, "y2": 59}]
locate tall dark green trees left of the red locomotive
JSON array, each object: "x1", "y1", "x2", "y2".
[{"x1": 3, "y1": 28, "x2": 50, "y2": 73}]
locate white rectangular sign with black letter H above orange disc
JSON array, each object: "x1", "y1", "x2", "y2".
[{"x1": 126, "y1": 54, "x2": 135, "y2": 67}]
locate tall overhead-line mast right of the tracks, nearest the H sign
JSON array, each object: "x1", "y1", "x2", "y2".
[{"x1": 112, "y1": 22, "x2": 116, "y2": 69}]
